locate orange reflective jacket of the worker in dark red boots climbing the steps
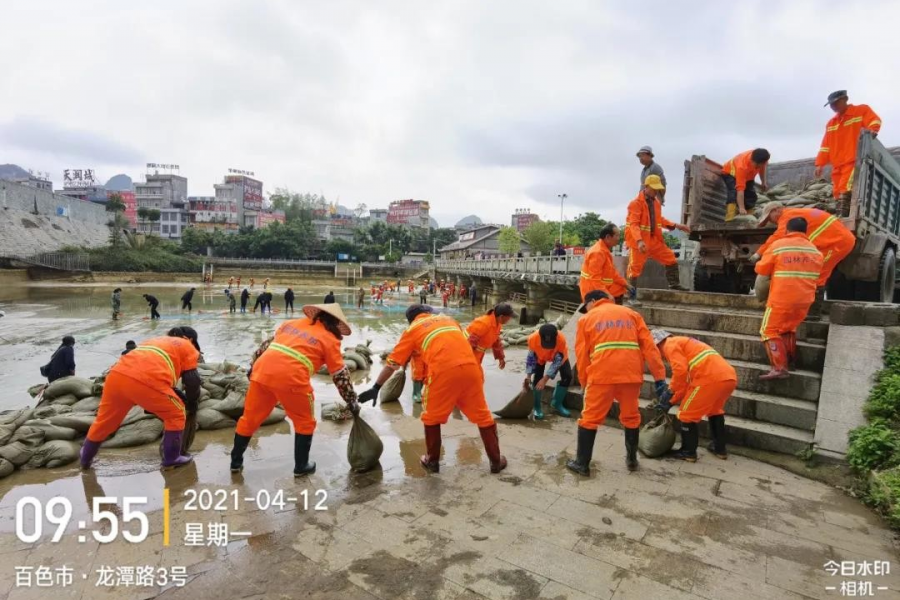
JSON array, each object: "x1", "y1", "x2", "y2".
[{"x1": 756, "y1": 230, "x2": 824, "y2": 308}]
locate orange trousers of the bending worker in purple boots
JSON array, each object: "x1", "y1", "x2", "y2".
[{"x1": 87, "y1": 371, "x2": 185, "y2": 442}]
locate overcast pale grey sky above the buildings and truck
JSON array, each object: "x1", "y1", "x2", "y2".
[{"x1": 0, "y1": 0, "x2": 900, "y2": 226}]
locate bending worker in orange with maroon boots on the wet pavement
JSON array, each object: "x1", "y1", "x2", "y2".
[{"x1": 359, "y1": 304, "x2": 506, "y2": 473}]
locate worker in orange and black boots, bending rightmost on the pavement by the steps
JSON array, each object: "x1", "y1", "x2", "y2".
[{"x1": 651, "y1": 329, "x2": 737, "y2": 462}]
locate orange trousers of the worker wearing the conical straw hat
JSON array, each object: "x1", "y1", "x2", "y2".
[{"x1": 235, "y1": 381, "x2": 316, "y2": 437}]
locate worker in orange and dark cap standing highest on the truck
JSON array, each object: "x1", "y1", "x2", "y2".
[{"x1": 810, "y1": 90, "x2": 881, "y2": 217}]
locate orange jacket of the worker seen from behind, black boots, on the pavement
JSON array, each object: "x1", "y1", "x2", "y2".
[{"x1": 575, "y1": 299, "x2": 666, "y2": 384}]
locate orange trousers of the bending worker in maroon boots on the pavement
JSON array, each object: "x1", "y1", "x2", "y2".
[{"x1": 422, "y1": 365, "x2": 494, "y2": 427}]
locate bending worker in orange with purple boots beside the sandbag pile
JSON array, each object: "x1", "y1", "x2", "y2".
[{"x1": 81, "y1": 327, "x2": 201, "y2": 469}]
